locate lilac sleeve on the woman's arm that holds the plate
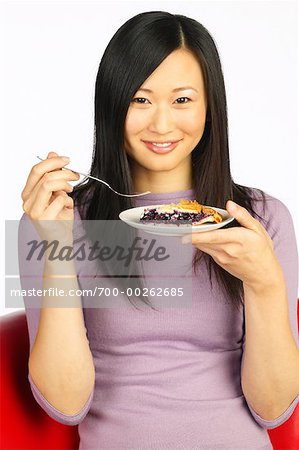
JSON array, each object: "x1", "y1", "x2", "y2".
[{"x1": 241, "y1": 194, "x2": 299, "y2": 428}]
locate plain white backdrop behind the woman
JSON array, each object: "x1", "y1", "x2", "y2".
[{"x1": 0, "y1": 0, "x2": 299, "y2": 315}]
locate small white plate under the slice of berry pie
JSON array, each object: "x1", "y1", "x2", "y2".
[{"x1": 119, "y1": 205, "x2": 234, "y2": 236}]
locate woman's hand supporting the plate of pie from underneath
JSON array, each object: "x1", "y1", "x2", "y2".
[{"x1": 183, "y1": 200, "x2": 283, "y2": 289}]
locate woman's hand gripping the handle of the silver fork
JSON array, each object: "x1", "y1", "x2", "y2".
[{"x1": 22, "y1": 152, "x2": 80, "y2": 240}]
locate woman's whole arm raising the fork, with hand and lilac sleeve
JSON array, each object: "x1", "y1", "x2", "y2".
[{"x1": 18, "y1": 152, "x2": 95, "y2": 418}]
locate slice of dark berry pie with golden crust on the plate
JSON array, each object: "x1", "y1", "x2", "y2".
[{"x1": 140, "y1": 199, "x2": 223, "y2": 226}]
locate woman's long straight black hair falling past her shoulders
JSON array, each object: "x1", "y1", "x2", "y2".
[{"x1": 72, "y1": 11, "x2": 265, "y2": 308}]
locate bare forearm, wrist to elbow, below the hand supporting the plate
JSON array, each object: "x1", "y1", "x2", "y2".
[{"x1": 241, "y1": 274, "x2": 299, "y2": 420}]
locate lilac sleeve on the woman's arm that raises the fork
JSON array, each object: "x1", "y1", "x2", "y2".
[{"x1": 18, "y1": 209, "x2": 94, "y2": 425}]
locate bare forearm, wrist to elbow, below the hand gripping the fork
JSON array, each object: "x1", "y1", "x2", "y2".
[{"x1": 29, "y1": 255, "x2": 95, "y2": 415}]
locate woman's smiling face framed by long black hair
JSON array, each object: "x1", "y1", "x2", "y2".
[{"x1": 125, "y1": 49, "x2": 207, "y2": 172}]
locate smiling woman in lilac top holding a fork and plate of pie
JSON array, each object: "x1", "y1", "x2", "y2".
[{"x1": 20, "y1": 11, "x2": 299, "y2": 450}]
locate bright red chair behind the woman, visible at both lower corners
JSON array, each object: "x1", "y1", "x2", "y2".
[{"x1": 0, "y1": 307, "x2": 299, "y2": 450}]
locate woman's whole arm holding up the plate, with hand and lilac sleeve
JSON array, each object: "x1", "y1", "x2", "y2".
[{"x1": 191, "y1": 196, "x2": 299, "y2": 428}]
